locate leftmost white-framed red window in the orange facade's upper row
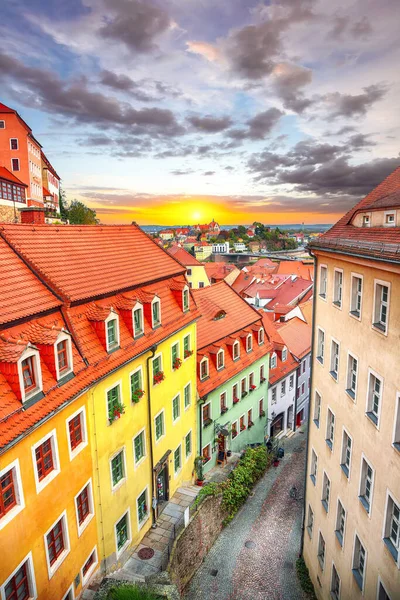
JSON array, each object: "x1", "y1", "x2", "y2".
[{"x1": 0, "y1": 459, "x2": 25, "y2": 531}]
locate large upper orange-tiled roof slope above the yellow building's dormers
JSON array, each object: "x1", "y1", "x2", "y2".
[{"x1": 0, "y1": 224, "x2": 184, "y2": 302}]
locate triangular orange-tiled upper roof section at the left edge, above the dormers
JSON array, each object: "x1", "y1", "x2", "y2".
[{"x1": 0, "y1": 238, "x2": 61, "y2": 325}]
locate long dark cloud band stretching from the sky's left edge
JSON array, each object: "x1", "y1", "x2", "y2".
[{"x1": 0, "y1": 53, "x2": 184, "y2": 136}]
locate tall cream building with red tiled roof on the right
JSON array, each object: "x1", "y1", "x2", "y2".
[{"x1": 303, "y1": 168, "x2": 400, "y2": 600}]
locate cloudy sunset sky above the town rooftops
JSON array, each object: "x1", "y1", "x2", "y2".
[{"x1": 0, "y1": 0, "x2": 400, "y2": 225}]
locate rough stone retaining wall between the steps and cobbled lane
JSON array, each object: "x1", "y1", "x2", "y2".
[{"x1": 168, "y1": 496, "x2": 227, "y2": 592}]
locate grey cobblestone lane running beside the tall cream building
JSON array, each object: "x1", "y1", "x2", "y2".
[{"x1": 184, "y1": 432, "x2": 306, "y2": 600}]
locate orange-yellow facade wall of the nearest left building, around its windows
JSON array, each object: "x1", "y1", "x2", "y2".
[{"x1": 0, "y1": 395, "x2": 97, "y2": 600}]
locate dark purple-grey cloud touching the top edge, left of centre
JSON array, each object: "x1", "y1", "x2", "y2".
[{"x1": 99, "y1": 0, "x2": 171, "y2": 53}]
